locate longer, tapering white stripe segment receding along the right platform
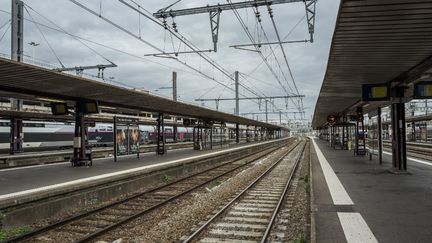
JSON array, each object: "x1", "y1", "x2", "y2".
[{"x1": 311, "y1": 139, "x2": 354, "y2": 205}]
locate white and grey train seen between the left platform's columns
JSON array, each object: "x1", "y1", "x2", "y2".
[{"x1": 0, "y1": 120, "x2": 192, "y2": 152}]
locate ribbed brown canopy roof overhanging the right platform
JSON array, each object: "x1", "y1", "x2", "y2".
[{"x1": 312, "y1": 0, "x2": 432, "y2": 127}]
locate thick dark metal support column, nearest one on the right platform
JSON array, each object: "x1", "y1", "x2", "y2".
[{"x1": 391, "y1": 103, "x2": 407, "y2": 171}]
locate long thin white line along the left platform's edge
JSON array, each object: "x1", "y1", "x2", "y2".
[{"x1": 0, "y1": 139, "x2": 279, "y2": 200}]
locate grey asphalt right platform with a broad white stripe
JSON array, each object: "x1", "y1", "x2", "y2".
[{"x1": 311, "y1": 139, "x2": 432, "y2": 243}]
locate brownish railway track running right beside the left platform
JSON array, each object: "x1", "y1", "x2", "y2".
[{"x1": 7, "y1": 140, "x2": 294, "y2": 242}]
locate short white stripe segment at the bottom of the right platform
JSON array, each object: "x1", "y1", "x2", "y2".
[{"x1": 338, "y1": 213, "x2": 378, "y2": 243}]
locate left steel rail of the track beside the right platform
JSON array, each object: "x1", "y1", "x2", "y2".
[{"x1": 183, "y1": 142, "x2": 301, "y2": 243}]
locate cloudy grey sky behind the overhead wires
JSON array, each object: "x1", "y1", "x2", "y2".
[{"x1": 0, "y1": 0, "x2": 339, "y2": 124}]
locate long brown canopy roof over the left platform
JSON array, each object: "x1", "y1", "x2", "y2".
[{"x1": 0, "y1": 58, "x2": 281, "y2": 128}]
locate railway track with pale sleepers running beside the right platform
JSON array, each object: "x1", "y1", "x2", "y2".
[{"x1": 183, "y1": 138, "x2": 308, "y2": 243}]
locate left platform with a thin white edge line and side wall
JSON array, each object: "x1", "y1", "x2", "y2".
[{"x1": 0, "y1": 139, "x2": 284, "y2": 208}]
